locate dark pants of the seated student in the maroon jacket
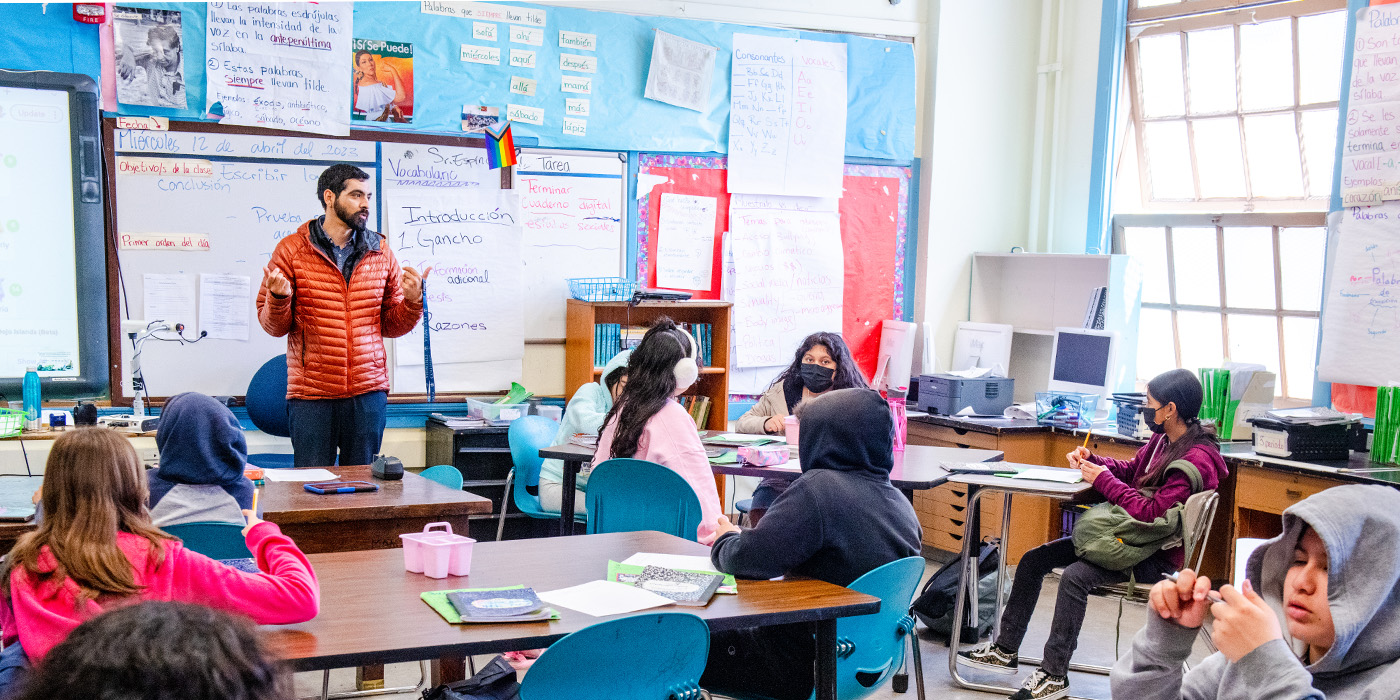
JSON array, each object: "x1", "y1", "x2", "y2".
[{"x1": 997, "y1": 538, "x2": 1176, "y2": 676}]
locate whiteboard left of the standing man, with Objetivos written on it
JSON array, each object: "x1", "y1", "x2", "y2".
[{"x1": 115, "y1": 154, "x2": 378, "y2": 396}]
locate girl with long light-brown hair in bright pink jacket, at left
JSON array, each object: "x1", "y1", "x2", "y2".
[{"x1": 0, "y1": 428, "x2": 321, "y2": 672}]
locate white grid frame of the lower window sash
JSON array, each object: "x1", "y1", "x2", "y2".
[{"x1": 1112, "y1": 211, "x2": 1327, "y2": 406}]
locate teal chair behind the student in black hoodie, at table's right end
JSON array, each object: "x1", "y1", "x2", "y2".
[{"x1": 715, "y1": 557, "x2": 924, "y2": 700}]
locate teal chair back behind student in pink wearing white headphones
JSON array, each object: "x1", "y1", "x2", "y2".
[{"x1": 585, "y1": 459, "x2": 700, "y2": 542}]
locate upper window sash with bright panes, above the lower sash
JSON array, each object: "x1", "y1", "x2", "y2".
[{"x1": 1114, "y1": 0, "x2": 1347, "y2": 213}]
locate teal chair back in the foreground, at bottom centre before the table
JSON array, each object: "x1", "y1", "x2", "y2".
[{"x1": 521, "y1": 613, "x2": 710, "y2": 700}]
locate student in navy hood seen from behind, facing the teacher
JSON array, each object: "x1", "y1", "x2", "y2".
[{"x1": 146, "y1": 392, "x2": 253, "y2": 528}]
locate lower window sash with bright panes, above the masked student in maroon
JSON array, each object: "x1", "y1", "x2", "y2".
[{"x1": 1113, "y1": 211, "x2": 1327, "y2": 405}]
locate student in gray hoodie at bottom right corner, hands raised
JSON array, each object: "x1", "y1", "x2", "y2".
[{"x1": 1112, "y1": 486, "x2": 1400, "y2": 700}]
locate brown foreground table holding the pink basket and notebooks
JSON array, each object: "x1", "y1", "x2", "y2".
[{"x1": 263, "y1": 532, "x2": 879, "y2": 700}]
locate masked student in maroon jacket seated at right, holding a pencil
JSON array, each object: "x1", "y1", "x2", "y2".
[{"x1": 958, "y1": 370, "x2": 1226, "y2": 700}]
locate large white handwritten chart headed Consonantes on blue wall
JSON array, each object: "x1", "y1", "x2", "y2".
[{"x1": 728, "y1": 34, "x2": 846, "y2": 197}]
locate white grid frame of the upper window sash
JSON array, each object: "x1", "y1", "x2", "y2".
[{"x1": 1124, "y1": 0, "x2": 1347, "y2": 213}]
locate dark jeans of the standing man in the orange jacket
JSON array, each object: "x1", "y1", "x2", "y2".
[{"x1": 287, "y1": 392, "x2": 389, "y2": 468}]
